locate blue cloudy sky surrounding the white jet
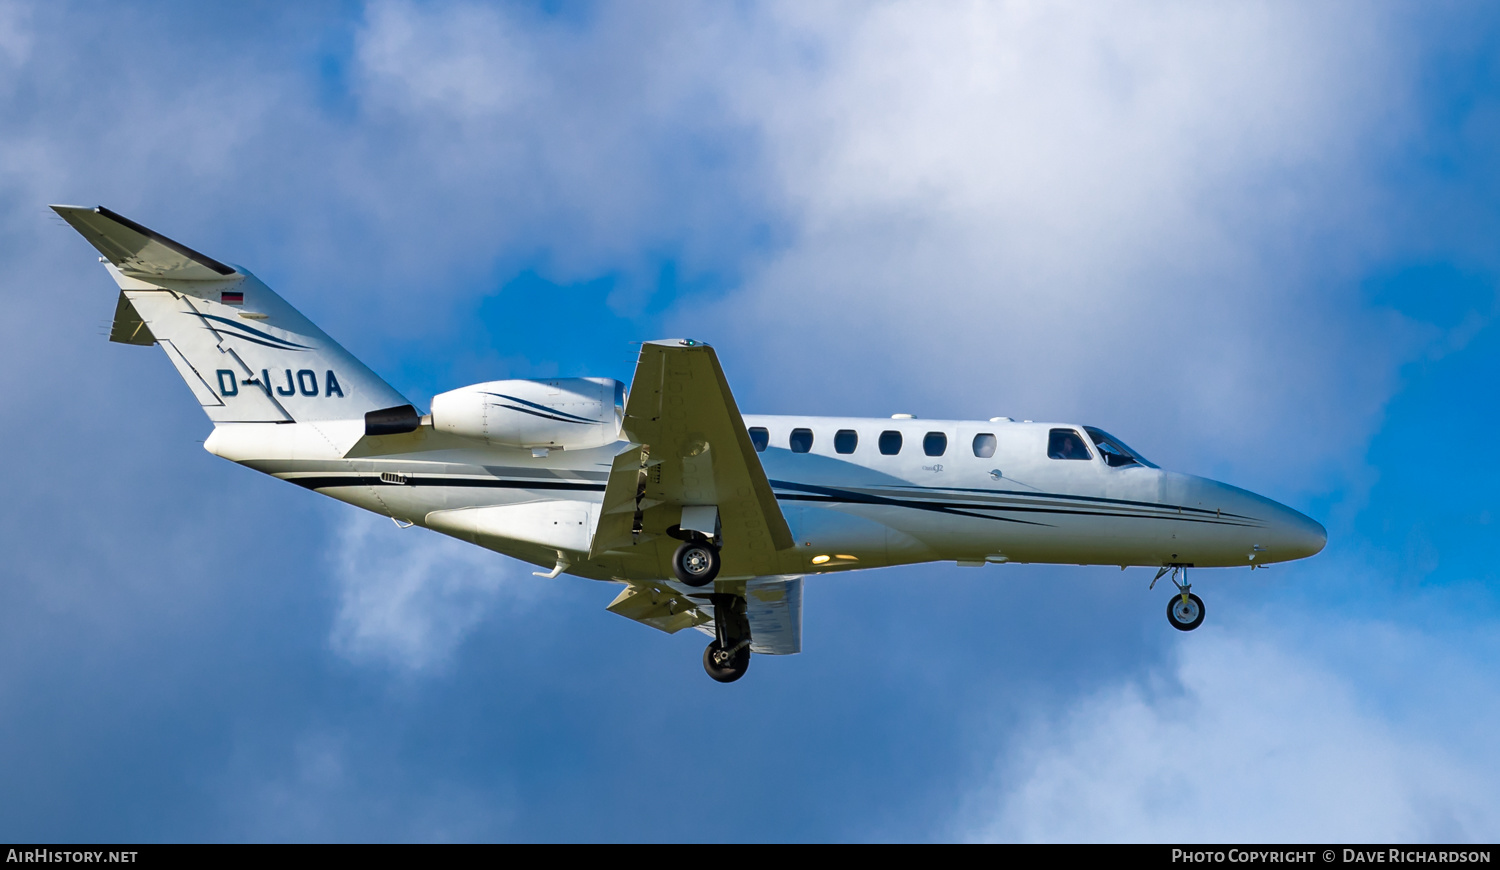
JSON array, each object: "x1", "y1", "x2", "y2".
[{"x1": 0, "y1": 0, "x2": 1500, "y2": 842}]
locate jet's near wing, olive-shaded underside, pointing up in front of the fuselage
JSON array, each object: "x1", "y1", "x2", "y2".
[{"x1": 590, "y1": 341, "x2": 795, "y2": 579}]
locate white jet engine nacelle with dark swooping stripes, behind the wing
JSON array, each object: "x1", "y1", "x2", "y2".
[{"x1": 432, "y1": 378, "x2": 626, "y2": 450}]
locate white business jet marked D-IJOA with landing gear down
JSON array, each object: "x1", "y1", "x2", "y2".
[{"x1": 53, "y1": 206, "x2": 1328, "y2": 683}]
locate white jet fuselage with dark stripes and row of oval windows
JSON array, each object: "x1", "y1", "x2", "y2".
[{"x1": 206, "y1": 414, "x2": 1326, "y2": 582}]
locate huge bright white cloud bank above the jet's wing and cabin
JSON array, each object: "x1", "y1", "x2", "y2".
[{"x1": 319, "y1": 2, "x2": 1431, "y2": 488}]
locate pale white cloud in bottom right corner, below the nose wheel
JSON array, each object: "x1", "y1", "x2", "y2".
[{"x1": 962, "y1": 621, "x2": 1500, "y2": 843}]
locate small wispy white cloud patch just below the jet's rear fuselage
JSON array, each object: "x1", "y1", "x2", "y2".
[{"x1": 332, "y1": 512, "x2": 539, "y2": 674}]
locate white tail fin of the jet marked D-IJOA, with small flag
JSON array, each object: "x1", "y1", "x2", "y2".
[{"x1": 53, "y1": 206, "x2": 407, "y2": 423}]
